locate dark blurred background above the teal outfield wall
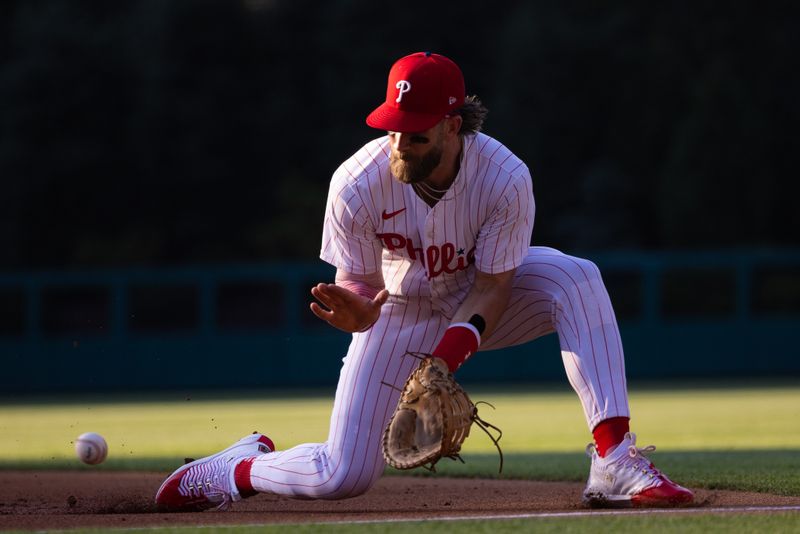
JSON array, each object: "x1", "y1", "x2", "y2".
[{"x1": 0, "y1": 0, "x2": 800, "y2": 270}]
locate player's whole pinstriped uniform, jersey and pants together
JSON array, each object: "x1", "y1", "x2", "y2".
[{"x1": 251, "y1": 134, "x2": 628, "y2": 499}]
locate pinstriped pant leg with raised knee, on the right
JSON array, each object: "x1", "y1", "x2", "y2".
[{"x1": 480, "y1": 247, "x2": 630, "y2": 429}]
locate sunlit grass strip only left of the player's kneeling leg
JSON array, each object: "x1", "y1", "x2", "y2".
[{"x1": 0, "y1": 398, "x2": 331, "y2": 466}]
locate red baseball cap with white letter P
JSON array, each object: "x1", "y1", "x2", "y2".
[{"x1": 367, "y1": 52, "x2": 465, "y2": 133}]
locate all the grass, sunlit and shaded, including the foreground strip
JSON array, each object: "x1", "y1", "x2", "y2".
[{"x1": 0, "y1": 386, "x2": 800, "y2": 534}]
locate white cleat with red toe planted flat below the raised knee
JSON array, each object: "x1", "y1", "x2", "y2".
[{"x1": 583, "y1": 432, "x2": 694, "y2": 507}]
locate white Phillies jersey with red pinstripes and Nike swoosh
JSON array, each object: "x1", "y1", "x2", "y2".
[{"x1": 320, "y1": 133, "x2": 534, "y2": 317}]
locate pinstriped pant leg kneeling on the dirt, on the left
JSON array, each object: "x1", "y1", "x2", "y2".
[{"x1": 251, "y1": 299, "x2": 449, "y2": 499}]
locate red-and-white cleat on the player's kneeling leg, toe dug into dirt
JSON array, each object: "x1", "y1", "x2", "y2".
[{"x1": 156, "y1": 433, "x2": 275, "y2": 512}]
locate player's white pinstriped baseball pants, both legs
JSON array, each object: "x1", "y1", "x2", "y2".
[{"x1": 251, "y1": 247, "x2": 629, "y2": 499}]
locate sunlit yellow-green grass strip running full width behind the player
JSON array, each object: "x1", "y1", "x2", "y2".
[{"x1": 0, "y1": 387, "x2": 800, "y2": 464}]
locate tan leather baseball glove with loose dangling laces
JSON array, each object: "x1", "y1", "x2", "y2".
[{"x1": 383, "y1": 353, "x2": 503, "y2": 471}]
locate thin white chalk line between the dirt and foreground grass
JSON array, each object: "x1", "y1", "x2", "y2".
[{"x1": 304, "y1": 505, "x2": 800, "y2": 526}]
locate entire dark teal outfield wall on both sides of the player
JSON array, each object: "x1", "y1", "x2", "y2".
[{"x1": 0, "y1": 251, "x2": 800, "y2": 394}]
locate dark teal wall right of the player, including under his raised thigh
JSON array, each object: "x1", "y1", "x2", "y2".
[{"x1": 459, "y1": 251, "x2": 800, "y2": 382}]
